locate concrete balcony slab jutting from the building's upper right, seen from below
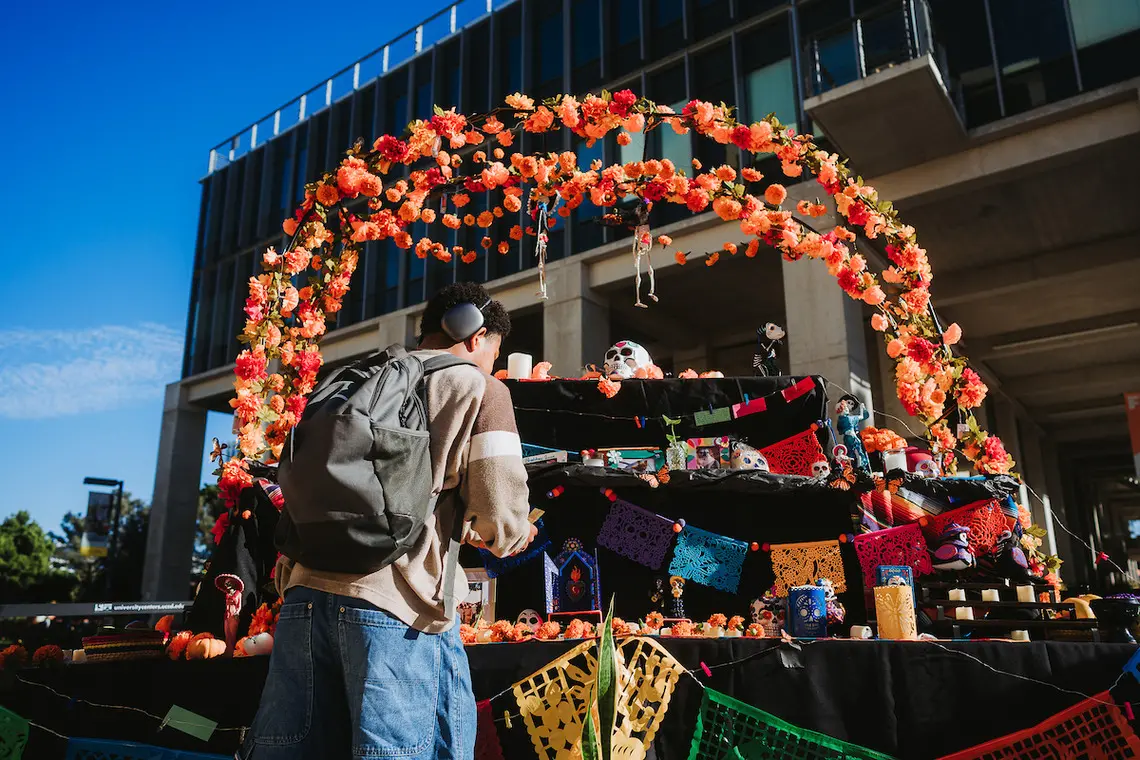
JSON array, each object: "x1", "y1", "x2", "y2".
[{"x1": 804, "y1": 55, "x2": 967, "y2": 177}]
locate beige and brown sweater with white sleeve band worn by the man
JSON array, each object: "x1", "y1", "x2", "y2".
[{"x1": 277, "y1": 351, "x2": 530, "y2": 634}]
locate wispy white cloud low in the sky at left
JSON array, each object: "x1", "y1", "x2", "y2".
[{"x1": 0, "y1": 324, "x2": 182, "y2": 419}]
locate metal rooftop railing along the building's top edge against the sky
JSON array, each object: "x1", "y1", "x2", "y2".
[{"x1": 206, "y1": 0, "x2": 515, "y2": 174}]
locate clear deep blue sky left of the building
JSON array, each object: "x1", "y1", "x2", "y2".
[{"x1": 0, "y1": 0, "x2": 447, "y2": 530}]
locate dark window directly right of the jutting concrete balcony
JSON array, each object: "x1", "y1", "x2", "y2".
[{"x1": 988, "y1": 0, "x2": 1077, "y2": 116}]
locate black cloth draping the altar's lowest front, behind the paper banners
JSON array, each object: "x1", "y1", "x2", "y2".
[{"x1": 0, "y1": 639, "x2": 1140, "y2": 760}]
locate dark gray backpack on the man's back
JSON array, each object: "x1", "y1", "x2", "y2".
[{"x1": 276, "y1": 345, "x2": 473, "y2": 573}]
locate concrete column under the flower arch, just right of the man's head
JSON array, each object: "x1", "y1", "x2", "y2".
[{"x1": 542, "y1": 259, "x2": 612, "y2": 377}]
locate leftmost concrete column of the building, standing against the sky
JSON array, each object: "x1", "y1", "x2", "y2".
[{"x1": 143, "y1": 383, "x2": 206, "y2": 600}]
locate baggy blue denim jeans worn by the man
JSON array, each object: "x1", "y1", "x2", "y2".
[{"x1": 235, "y1": 587, "x2": 475, "y2": 760}]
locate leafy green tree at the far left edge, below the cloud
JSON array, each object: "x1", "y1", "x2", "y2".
[{"x1": 0, "y1": 512, "x2": 73, "y2": 603}]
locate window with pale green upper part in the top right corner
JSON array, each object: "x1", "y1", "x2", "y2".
[{"x1": 1069, "y1": 0, "x2": 1140, "y2": 90}]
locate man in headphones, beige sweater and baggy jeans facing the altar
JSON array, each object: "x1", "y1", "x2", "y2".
[{"x1": 237, "y1": 283, "x2": 536, "y2": 760}]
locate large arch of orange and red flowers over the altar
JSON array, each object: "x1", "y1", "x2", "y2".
[{"x1": 219, "y1": 90, "x2": 1013, "y2": 500}]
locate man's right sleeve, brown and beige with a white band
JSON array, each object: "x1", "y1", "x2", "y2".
[{"x1": 461, "y1": 377, "x2": 532, "y2": 557}]
